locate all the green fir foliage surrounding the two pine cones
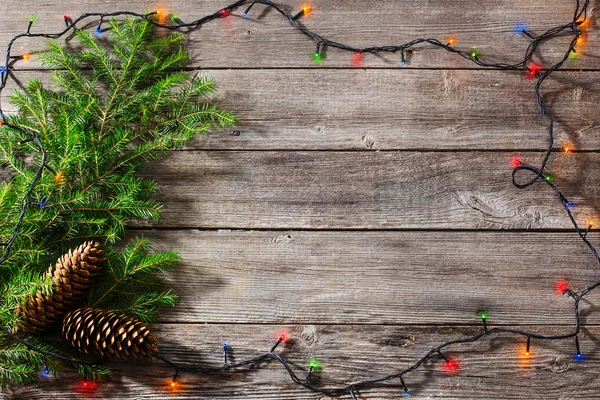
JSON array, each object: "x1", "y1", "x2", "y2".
[{"x1": 0, "y1": 18, "x2": 235, "y2": 384}]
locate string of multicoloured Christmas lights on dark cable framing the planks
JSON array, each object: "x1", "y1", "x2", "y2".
[{"x1": 0, "y1": 0, "x2": 600, "y2": 399}]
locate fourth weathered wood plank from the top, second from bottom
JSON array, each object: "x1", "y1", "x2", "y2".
[{"x1": 133, "y1": 230, "x2": 598, "y2": 324}]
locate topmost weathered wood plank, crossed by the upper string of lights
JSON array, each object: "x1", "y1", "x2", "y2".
[{"x1": 0, "y1": 0, "x2": 600, "y2": 69}]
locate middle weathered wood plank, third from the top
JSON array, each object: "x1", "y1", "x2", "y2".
[{"x1": 138, "y1": 151, "x2": 600, "y2": 229}]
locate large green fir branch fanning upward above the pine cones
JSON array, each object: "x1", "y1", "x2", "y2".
[{"x1": 0, "y1": 19, "x2": 235, "y2": 271}]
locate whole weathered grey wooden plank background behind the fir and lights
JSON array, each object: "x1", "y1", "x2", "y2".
[{"x1": 0, "y1": 0, "x2": 600, "y2": 399}]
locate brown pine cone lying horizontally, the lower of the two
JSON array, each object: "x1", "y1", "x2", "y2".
[{"x1": 62, "y1": 308, "x2": 158, "y2": 359}]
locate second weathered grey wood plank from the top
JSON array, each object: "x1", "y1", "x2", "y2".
[{"x1": 2, "y1": 70, "x2": 600, "y2": 150}]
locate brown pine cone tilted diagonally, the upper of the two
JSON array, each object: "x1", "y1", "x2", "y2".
[{"x1": 21, "y1": 242, "x2": 105, "y2": 333}]
